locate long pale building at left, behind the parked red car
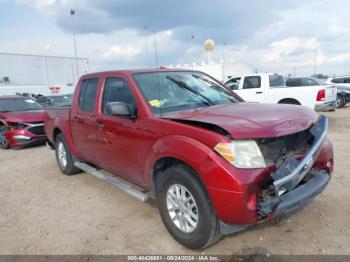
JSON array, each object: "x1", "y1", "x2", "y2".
[{"x1": 0, "y1": 53, "x2": 89, "y2": 95}]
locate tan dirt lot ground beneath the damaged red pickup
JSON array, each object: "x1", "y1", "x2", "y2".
[{"x1": 0, "y1": 107, "x2": 350, "y2": 255}]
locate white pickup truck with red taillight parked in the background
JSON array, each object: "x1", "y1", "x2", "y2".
[{"x1": 225, "y1": 73, "x2": 337, "y2": 111}]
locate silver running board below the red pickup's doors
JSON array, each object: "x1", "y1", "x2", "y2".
[{"x1": 74, "y1": 162, "x2": 148, "y2": 202}]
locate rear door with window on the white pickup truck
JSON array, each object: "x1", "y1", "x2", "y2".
[{"x1": 235, "y1": 75, "x2": 265, "y2": 103}]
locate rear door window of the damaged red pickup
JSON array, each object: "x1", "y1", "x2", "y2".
[{"x1": 78, "y1": 78, "x2": 98, "y2": 113}]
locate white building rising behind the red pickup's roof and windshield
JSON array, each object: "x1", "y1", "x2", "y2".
[{"x1": 169, "y1": 59, "x2": 257, "y2": 82}]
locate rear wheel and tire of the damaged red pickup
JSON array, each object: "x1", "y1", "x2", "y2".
[{"x1": 55, "y1": 134, "x2": 80, "y2": 176}]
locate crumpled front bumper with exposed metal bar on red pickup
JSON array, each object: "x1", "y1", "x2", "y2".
[{"x1": 221, "y1": 116, "x2": 333, "y2": 234}]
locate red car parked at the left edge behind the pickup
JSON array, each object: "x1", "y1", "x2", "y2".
[{"x1": 0, "y1": 96, "x2": 46, "y2": 149}]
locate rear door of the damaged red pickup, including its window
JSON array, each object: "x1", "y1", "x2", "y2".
[{"x1": 71, "y1": 78, "x2": 99, "y2": 163}]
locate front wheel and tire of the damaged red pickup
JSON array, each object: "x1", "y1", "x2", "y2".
[{"x1": 157, "y1": 164, "x2": 221, "y2": 249}]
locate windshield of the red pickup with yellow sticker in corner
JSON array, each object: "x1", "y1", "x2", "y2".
[{"x1": 134, "y1": 72, "x2": 241, "y2": 114}]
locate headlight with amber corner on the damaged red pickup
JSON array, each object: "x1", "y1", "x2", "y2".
[{"x1": 214, "y1": 140, "x2": 266, "y2": 168}]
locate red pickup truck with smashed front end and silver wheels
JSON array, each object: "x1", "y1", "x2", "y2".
[{"x1": 45, "y1": 69, "x2": 333, "y2": 249}]
